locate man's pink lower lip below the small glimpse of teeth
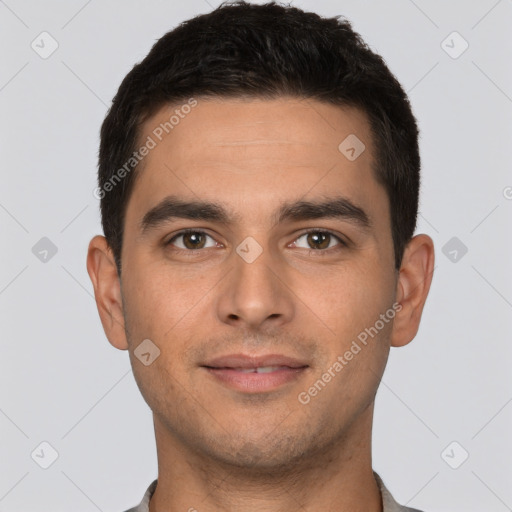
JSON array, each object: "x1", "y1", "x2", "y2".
[{"x1": 206, "y1": 366, "x2": 307, "y2": 393}]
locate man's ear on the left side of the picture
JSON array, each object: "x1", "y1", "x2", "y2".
[{"x1": 87, "y1": 235, "x2": 128, "y2": 350}]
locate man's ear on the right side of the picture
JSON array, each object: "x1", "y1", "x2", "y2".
[{"x1": 391, "y1": 235, "x2": 434, "y2": 347}]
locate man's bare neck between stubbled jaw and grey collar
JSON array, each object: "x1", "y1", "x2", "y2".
[{"x1": 149, "y1": 404, "x2": 382, "y2": 512}]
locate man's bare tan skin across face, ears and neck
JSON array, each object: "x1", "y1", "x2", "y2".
[{"x1": 87, "y1": 98, "x2": 434, "y2": 512}]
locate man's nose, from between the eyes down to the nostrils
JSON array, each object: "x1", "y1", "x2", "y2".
[{"x1": 218, "y1": 237, "x2": 293, "y2": 328}]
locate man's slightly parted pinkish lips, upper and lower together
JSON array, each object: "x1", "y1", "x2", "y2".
[{"x1": 202, "y1": 354, "x2": 309, "y2": 393}]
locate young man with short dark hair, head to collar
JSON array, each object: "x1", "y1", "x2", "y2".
[{"x1": 87, "y1": 2, "x2": 434, "y2": 512}]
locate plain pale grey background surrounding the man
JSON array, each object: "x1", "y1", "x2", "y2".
[{"x1": 0, "y1": 0, "x2": 512, "y2": 512}]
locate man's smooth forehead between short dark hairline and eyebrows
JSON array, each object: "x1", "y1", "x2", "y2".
[{"x1": 126, "y1": 98, "x2": 386, "y2": 230}]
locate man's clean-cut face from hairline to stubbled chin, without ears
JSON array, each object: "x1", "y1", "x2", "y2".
[{"x1": 91, "y1": 98, "x2": 416, "y2": 467}]
